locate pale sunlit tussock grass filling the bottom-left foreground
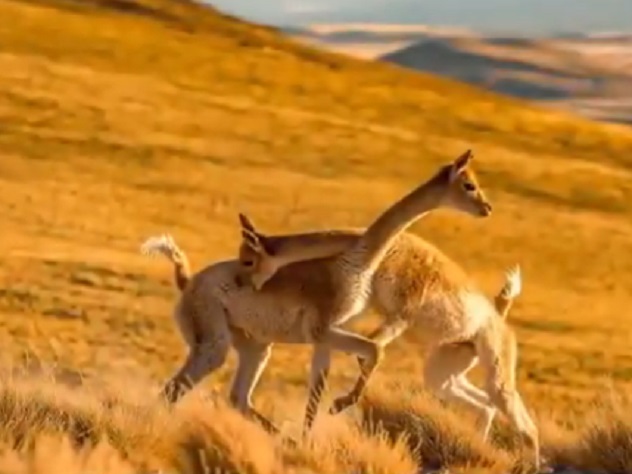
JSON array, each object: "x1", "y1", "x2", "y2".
[{"x1": 0, "y1": 366, "x2": 416, "y2": 474}]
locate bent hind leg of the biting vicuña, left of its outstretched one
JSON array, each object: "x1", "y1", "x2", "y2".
[{"x1": 424, "y1": 343, "x2": 496, "y2": 439}]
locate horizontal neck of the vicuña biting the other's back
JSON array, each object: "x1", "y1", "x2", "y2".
[{"x1": 265, "y1": 230, "x2": 362, "y2": 264}]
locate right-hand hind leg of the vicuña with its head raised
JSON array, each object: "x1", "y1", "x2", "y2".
[{"x1": 229, "y1": 330, "x2": 279, "y2": 433}]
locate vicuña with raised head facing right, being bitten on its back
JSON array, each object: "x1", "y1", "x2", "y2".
[{"x1": 143, "y1": 151, "x2": 490, "y2": 444}]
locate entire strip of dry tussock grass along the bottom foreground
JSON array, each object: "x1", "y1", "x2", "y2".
[{"x1": 0, "y1": 367, "x2": 632, "y2": 474}]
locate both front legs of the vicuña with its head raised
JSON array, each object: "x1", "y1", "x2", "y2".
[{"x1": 303, "y1": 327, "x2": 382, "y2": 434}]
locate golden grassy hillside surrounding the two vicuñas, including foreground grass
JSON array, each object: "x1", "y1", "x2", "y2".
[{"x1": 0, "y1": 0, "x2": 632, "y2": 474}]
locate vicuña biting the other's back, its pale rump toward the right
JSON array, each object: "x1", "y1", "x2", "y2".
[{"x1": 239, "y1": 224, "x2": 539, "y2": 462}]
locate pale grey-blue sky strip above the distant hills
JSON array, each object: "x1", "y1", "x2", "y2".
[{"x1": 207, "y1": 0, "x2": 632, "y2": 34}]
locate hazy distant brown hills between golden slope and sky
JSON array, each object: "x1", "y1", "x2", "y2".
[{"x1": 289, "y1": 23, "x2": 632, "y2": 125}]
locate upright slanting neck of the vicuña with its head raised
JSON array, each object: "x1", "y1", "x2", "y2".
[{"x1": 345, "y1": 176, "x2": 441, "y2": 270}]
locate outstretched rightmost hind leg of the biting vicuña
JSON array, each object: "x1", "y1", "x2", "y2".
[{"x1": 474, "y1": 328, "x2": 540, "y2": 468}]
